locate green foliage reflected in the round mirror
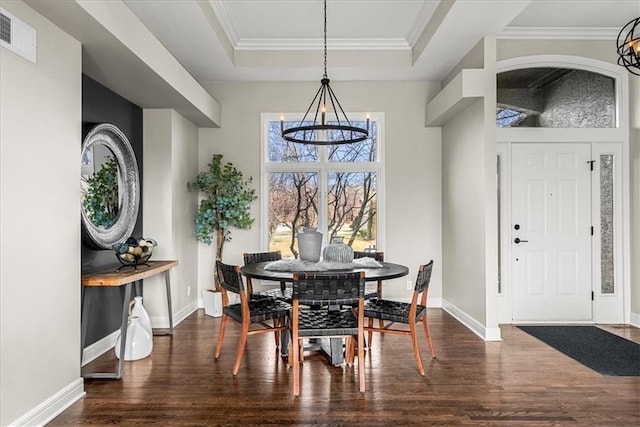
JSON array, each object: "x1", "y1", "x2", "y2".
[{"x1": 82, "y1": 157, "x2": 119, "y2": 228}]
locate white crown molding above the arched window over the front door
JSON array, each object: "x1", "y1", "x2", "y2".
[{"x1": 497, "y1": 27, "x2": 620, "y2": 40}]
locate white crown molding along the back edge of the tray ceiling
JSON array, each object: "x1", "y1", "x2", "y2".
[{"x1": 235, "y1": 38, "x2": 411, "y2": 51}]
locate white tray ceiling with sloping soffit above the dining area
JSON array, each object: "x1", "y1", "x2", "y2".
[{"x1": 24, "y1": 0, "x2": 640, "y2": 126}]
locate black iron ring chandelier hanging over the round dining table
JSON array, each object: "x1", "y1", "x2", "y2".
[{"x1": 280, "y1": 0, "x2": 369, "y2": 145}]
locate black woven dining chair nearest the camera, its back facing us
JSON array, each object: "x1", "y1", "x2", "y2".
[{"x1": 289, "y1": 272, "x2": 365, "y2": 396}]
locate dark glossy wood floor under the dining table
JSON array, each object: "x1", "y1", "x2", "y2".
[{"x1": 50, "y1": 309, "x2": 640, "y2": 426}]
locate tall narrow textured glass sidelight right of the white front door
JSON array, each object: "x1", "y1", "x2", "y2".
[{"x1": 600, "y1": 154, "x2": 615, "y2": 294}]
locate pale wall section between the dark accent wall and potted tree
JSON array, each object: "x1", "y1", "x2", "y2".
[{"x1": 142, "y1": 109, "x2": 198, "y2": 328}]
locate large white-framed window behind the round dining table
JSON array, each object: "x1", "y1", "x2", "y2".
[{"x1": 262, "y1": 114, "x2": 384, "y2": 258}]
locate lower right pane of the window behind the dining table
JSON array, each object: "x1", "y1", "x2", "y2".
[{"x1": 326, "y1": 172, "x2": 378, "y2": 251}]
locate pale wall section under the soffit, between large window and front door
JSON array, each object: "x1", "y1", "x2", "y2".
[{"x1": 442, "y1": 99, "x2": 487, "y2": 325}]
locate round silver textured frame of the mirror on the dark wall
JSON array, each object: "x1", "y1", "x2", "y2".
[{"x1": 80, "y1": 123, "x2": 140, "y2": 249}]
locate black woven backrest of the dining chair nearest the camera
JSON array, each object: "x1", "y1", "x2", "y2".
[{"x1": 293, "y1": 271, "x2": 364, "y2": 306}]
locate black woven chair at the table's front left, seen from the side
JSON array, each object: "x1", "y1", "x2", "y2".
[{"x1": 215, "y1": 261, "x2": 291, "y2": 375}]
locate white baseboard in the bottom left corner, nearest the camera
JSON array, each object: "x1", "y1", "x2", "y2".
[{"x1": 9, "y1": 378, "x2": 86, "y2": 427}]
